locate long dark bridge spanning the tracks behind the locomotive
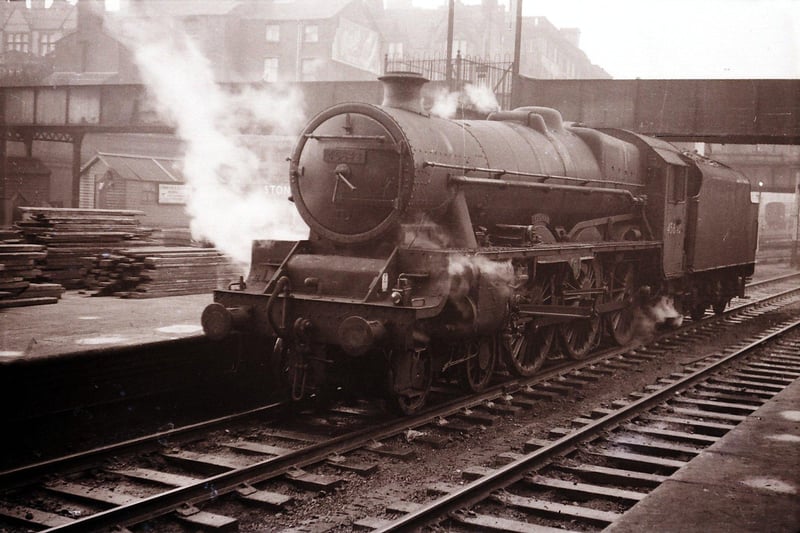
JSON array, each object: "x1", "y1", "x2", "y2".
[{"x1": 0, "y1": 77, "x2": 800, "y2": 222}]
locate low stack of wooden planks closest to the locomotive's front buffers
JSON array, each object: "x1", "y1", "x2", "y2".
[{"x1": 85, "y1": 246, "x2": 241, "y2": 298}]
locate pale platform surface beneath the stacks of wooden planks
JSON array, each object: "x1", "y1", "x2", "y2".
[{"x1": 0, "y1": 291, "x2": 213, "y2": 365}]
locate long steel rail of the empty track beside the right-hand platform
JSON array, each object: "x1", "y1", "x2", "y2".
[{"x1": 375, "y1": 320, "x2": 800, "y2": 532}]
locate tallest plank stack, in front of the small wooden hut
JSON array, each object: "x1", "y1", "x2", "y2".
[{"x1": 15, "y1": 207, "x2": 152, "y2": 289}]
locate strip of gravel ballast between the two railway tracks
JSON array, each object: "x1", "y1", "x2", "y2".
[{"x1": 223, "y1": 296, "x2": 800, "y2": 531}]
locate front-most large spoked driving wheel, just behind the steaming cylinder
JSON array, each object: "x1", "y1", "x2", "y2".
[{"x1": 503, "y1": 276, "x2": 555, "y2": 377}]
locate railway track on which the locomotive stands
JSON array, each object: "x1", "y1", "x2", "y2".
[{"x1": 0, "y1": 276, "x2": 798, "y2": 531}]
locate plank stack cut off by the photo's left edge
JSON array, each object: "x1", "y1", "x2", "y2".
[{"x1": 0, "y1": 243, "x2": 64, "y2": 309}]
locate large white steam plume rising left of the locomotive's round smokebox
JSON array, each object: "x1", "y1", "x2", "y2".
[{"x1": 107, "y1": 18, "x2": 307, "y2": 264}]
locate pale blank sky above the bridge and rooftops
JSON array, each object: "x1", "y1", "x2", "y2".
[{"x1": 414, "y1": 0, "x2": 800, "y2": 79}]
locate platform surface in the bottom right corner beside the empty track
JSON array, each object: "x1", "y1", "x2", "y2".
[{"x1": 605, "y1": 379, "x2": 800, "y2": 533}]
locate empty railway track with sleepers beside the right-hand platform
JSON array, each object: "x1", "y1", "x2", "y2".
[{"x1": 365, "y1": 320, "x2": 800, "y2": 532}]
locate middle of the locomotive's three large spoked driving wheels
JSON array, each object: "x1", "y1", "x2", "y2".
[{"x1": 558, "y1": 262, "x2": 601, "y2": 360}]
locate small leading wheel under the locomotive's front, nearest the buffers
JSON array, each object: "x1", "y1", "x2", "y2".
[{"x1": 387, "y1": 349, "x2": 433, "y2": 415}]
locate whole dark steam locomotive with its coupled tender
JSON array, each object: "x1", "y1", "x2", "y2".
[{"x1": 202, "y1": 73, "x2": 757, "y2": 413}]
